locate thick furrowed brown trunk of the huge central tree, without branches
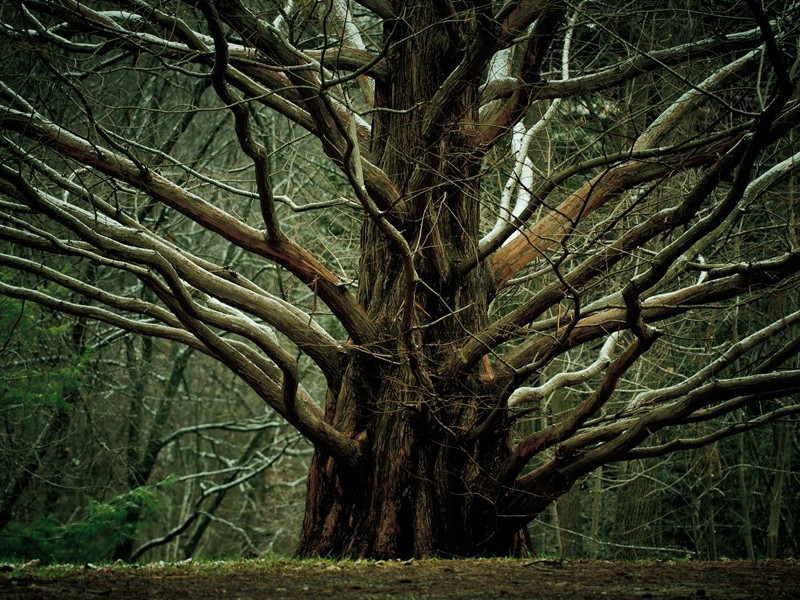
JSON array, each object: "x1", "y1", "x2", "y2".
[{"x1": 299, "y1": 6, "x2": 519, "y2": 557}]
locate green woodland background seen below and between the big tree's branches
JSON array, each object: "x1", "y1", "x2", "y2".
[{"x1": 0, "y1": 2, "x2": 800, "y2": 562}]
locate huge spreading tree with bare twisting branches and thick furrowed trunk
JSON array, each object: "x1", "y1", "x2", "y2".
[{"x1": 0, "y1": 0, "x2": 800, "y2": 557}]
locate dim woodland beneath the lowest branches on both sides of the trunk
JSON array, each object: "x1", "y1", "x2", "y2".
[{"x1": 0, "y1": 290, "x2": 800, "y2": 562}]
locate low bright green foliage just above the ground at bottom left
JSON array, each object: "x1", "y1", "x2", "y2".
[{"x1": 0, "y1": 484, "x2": 161, "y2": 563}]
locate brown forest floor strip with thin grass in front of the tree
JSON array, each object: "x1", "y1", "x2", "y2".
[{"x1": 0, "y1": 559, "x2": 800, "y2": 600}]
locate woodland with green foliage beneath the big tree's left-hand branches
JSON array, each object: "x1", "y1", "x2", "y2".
[{"x1": 0, "y1": 298, "x2": 310, "y2": 563}]
